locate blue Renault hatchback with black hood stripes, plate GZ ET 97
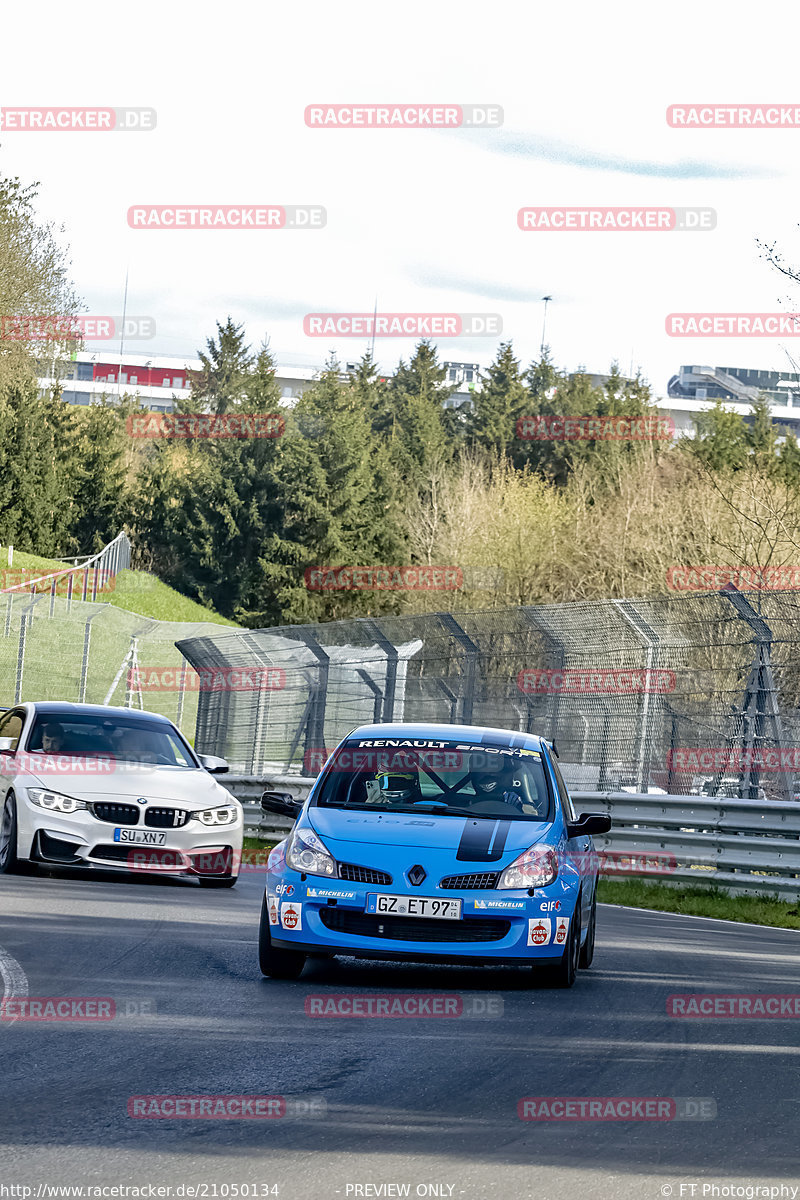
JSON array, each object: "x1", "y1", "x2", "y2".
[{"x1": 259, "y1": 724, "x2": 610, "y2": 988}]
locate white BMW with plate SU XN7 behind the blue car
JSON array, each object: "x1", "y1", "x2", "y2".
[{"x1": 0, "y1": 702, "x2": 243, "y2": 888}]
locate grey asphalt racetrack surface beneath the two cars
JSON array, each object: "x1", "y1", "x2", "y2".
[{"x1": 0, "y1": 874, "x2": 800, "y2": 1200}]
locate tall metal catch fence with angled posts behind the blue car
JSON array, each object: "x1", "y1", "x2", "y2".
[{"x1": 179, "y1": 586, "x2": 800, "y2": 800}]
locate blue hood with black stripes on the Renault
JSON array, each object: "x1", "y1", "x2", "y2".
[{"x1": 302, "y1": 805, "x2": 551, "y2": 863}]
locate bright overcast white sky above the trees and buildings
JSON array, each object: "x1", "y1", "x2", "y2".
[{"x1": 0, "y1": 0, "x2": 800, "y2": 395}]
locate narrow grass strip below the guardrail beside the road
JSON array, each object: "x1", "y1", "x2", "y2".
[{"x1": 597, "y1": 880, "x2": 800, "y2": 929}]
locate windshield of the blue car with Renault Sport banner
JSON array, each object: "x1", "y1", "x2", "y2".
[{"x1": 315, "y1": 742, "x2": 553, "y2": 821}]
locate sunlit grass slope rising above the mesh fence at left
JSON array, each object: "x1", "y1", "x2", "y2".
[{"x1": 0, "y1": 546, "x2": 237, "y2": 628}]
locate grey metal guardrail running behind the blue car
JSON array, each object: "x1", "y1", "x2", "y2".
[{"x1": 224, "y1": 775, "x2": 800, "y2": 900}]
